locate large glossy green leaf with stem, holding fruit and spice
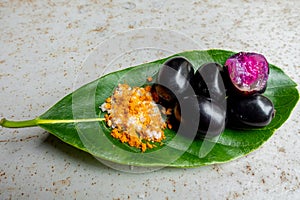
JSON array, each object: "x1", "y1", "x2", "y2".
[{"x1": 0, "y1": 50, "x2": 299, "y2": 167}]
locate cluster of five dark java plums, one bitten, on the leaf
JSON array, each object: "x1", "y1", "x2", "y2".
[{"x1": 153, "y1": 52, "x2": 275, "y2": 137}]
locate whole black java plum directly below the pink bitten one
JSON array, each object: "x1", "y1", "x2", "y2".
[{"x1": 227, "y1": 94, "x2": 275, "y2": 127}]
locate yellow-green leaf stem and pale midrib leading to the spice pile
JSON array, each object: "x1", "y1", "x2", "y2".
[{"x1": 0, "y1": 118, "x2": 105, "y2": 128}]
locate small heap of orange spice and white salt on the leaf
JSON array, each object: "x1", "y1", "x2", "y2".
[{"x1": 101, "y1": 84, "x2": 166, "y2": 152}]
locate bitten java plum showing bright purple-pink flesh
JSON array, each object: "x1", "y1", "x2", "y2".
[{"x1": 225, "y1": 52, "x2": 269, "y2": 95}]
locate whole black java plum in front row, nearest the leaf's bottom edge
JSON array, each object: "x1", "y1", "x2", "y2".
[{"x1": 174, "y1": 95, "x2": 226, "y2": 138}]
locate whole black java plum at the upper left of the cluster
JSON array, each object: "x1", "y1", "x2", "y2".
[{"x1": 154, "y1": 57, "x2": 194, "y2": 103}]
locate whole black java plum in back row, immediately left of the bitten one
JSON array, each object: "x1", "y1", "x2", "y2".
[{"x1": 192, "y1": 63, "x2": 226, "y2": 102}]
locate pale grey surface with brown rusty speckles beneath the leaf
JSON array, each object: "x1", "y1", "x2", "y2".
[{"x1": 0, "y1": 0, "x2": 300, "y2": 199}]
